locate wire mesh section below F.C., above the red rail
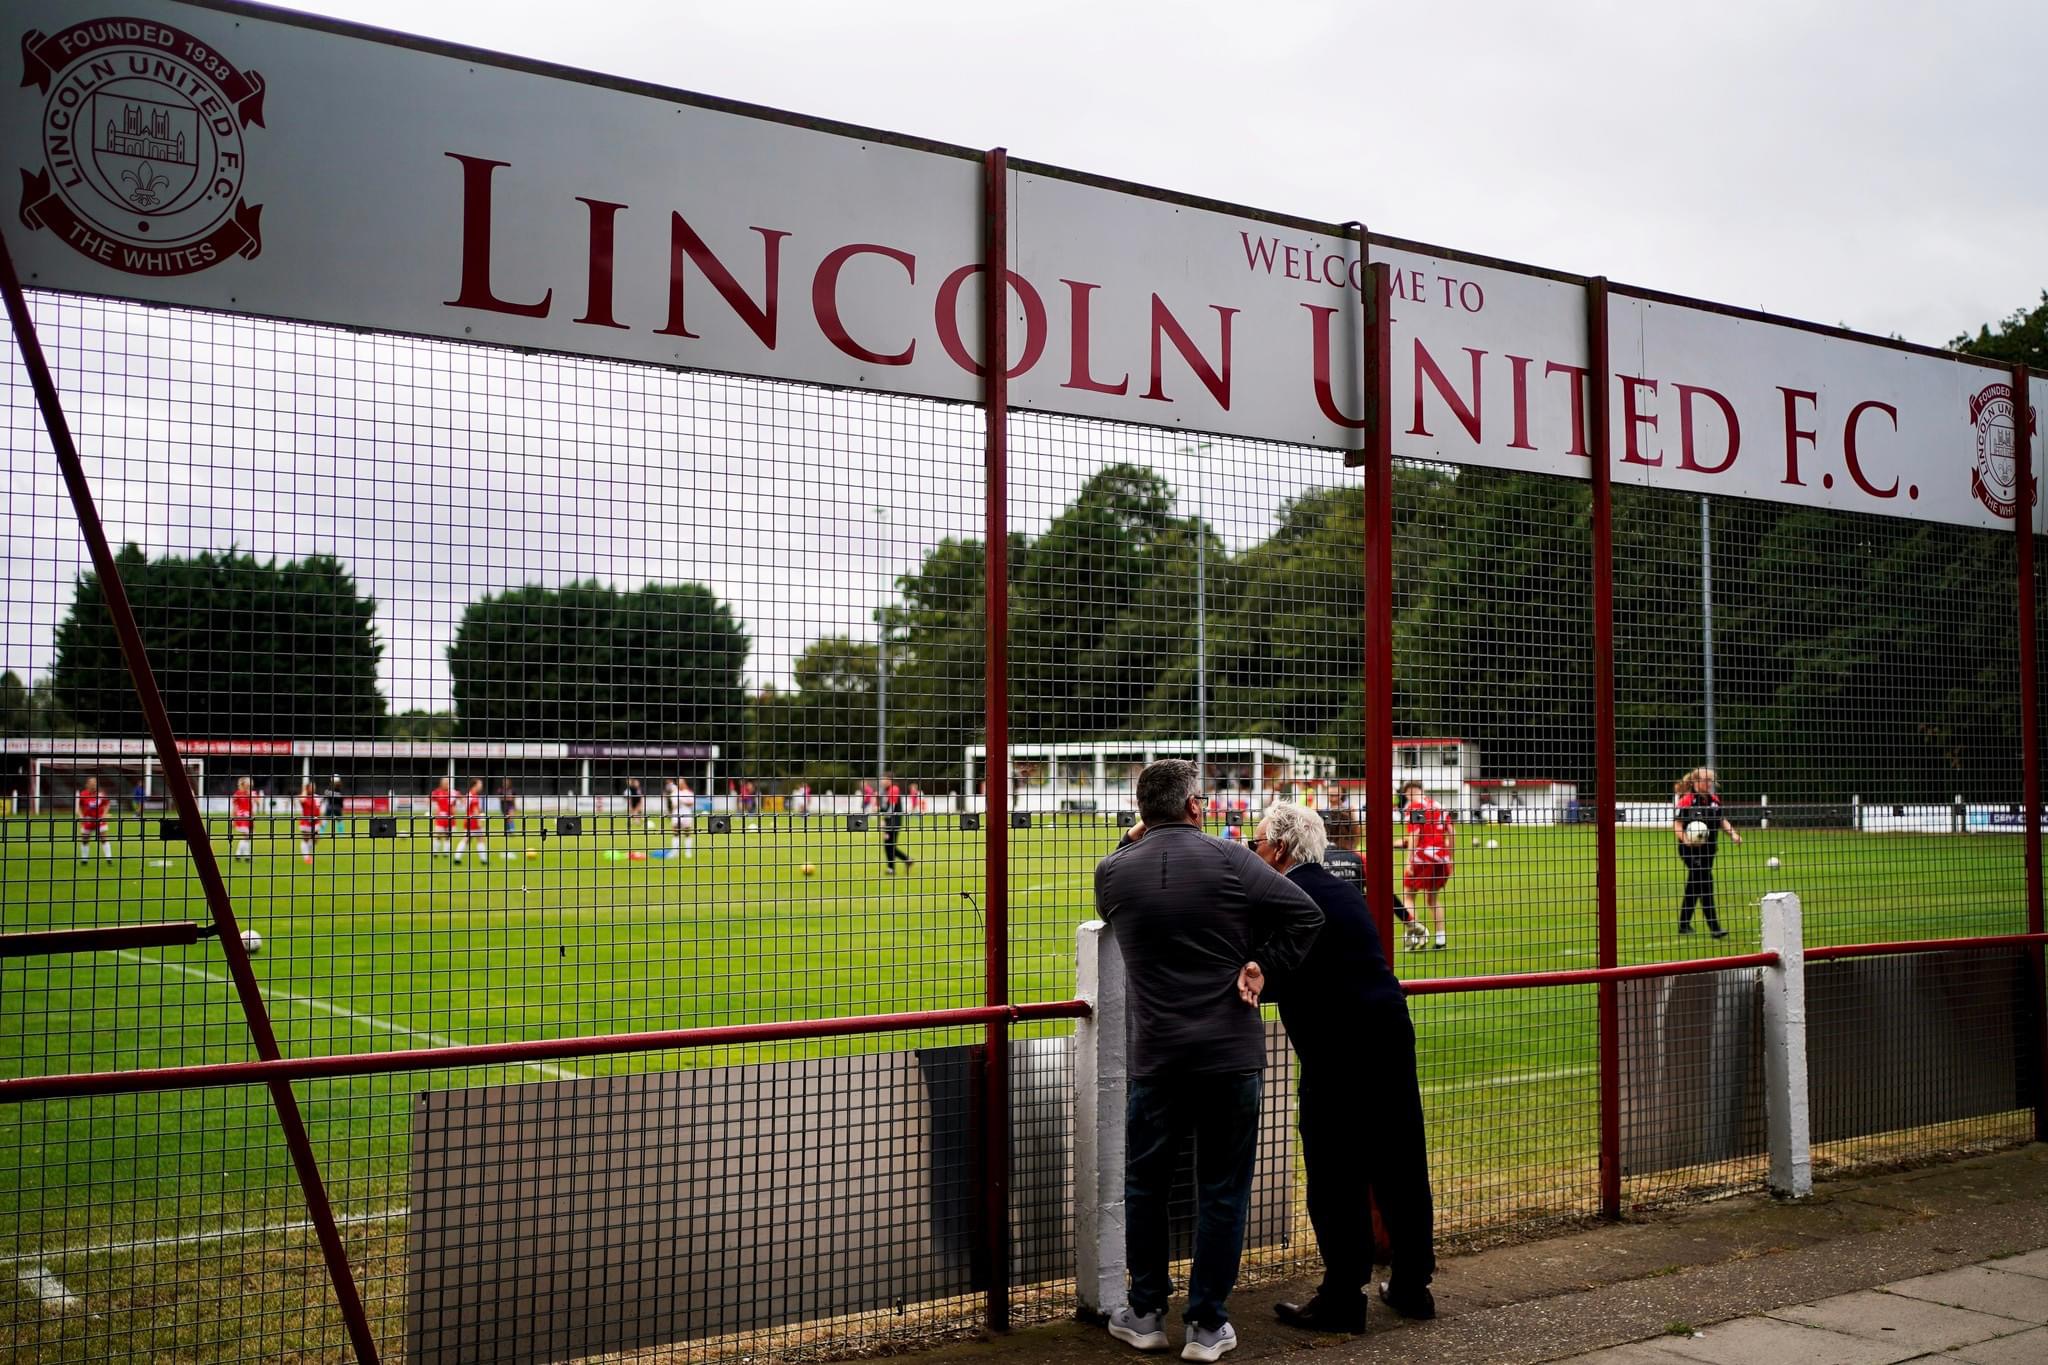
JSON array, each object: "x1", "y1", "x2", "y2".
[{"x1": 1616, "y1": 489, "x2": 2025, "y2": 954}]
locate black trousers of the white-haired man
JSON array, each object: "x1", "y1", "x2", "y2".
[{"x1": 1298, "y1": 1001, "x2": 1436, "y2": 1304}]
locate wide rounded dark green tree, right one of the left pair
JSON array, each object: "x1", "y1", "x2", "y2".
[{"x1": 449, "y1": 581, "x2": 750, "y2": 740}]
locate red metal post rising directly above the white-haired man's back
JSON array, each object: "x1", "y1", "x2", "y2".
[{"x1": 1358, "y1": 264, "x2": 1395, "y2": 960}]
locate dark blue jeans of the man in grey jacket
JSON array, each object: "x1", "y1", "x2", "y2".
[{"x1": 1124, "y1": 1070, "x2": 1266, "y2": 1328}]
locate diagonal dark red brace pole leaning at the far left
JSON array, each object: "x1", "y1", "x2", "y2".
[{"x1": 0, "y1": 235, "x2": 377, "y2": 1365}]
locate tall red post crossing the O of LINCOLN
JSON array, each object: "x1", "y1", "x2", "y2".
[{"x1": 981, "y1": 147, "x2": 1010, "y2": 1332}]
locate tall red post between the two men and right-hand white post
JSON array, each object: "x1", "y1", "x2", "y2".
[{"x1": 1585, "y1": 278, "x2": 1622, "y2": 1218}]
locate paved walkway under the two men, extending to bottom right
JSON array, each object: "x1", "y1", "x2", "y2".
[{"x1": 922, "y1": 1144, "x2": 2048, "y2": 1365}]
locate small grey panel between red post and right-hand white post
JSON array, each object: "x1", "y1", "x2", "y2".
[{"x1": 1616, "y1": 972, "x2": 1767, "y2": 1175}]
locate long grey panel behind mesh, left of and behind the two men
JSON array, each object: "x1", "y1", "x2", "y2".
[{"x1": 406, "y1": 1023, "x2": 1294, "y2": 1363}]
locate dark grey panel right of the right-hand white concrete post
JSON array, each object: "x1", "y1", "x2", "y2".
[{"x1": 1806, "y1": 952, "x2": 2032, "y2": 1142}]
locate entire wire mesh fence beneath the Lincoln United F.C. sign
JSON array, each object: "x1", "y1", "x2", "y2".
[{"x1": 0, "y1": 282, "x2": 2040, "y2": 1359}]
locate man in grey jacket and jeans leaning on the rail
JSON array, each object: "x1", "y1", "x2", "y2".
[{"x1": 1096, "y1": 759, "x2": 1323, "y2": 1361}]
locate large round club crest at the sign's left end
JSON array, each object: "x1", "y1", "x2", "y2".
[{"x1": 20, "y1": 18, "x2": 264, "y2": 276}]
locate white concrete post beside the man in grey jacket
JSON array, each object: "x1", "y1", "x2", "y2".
[{"x1": 1073, "y1": 919, "x2": 1130, "y2": 1314}]
